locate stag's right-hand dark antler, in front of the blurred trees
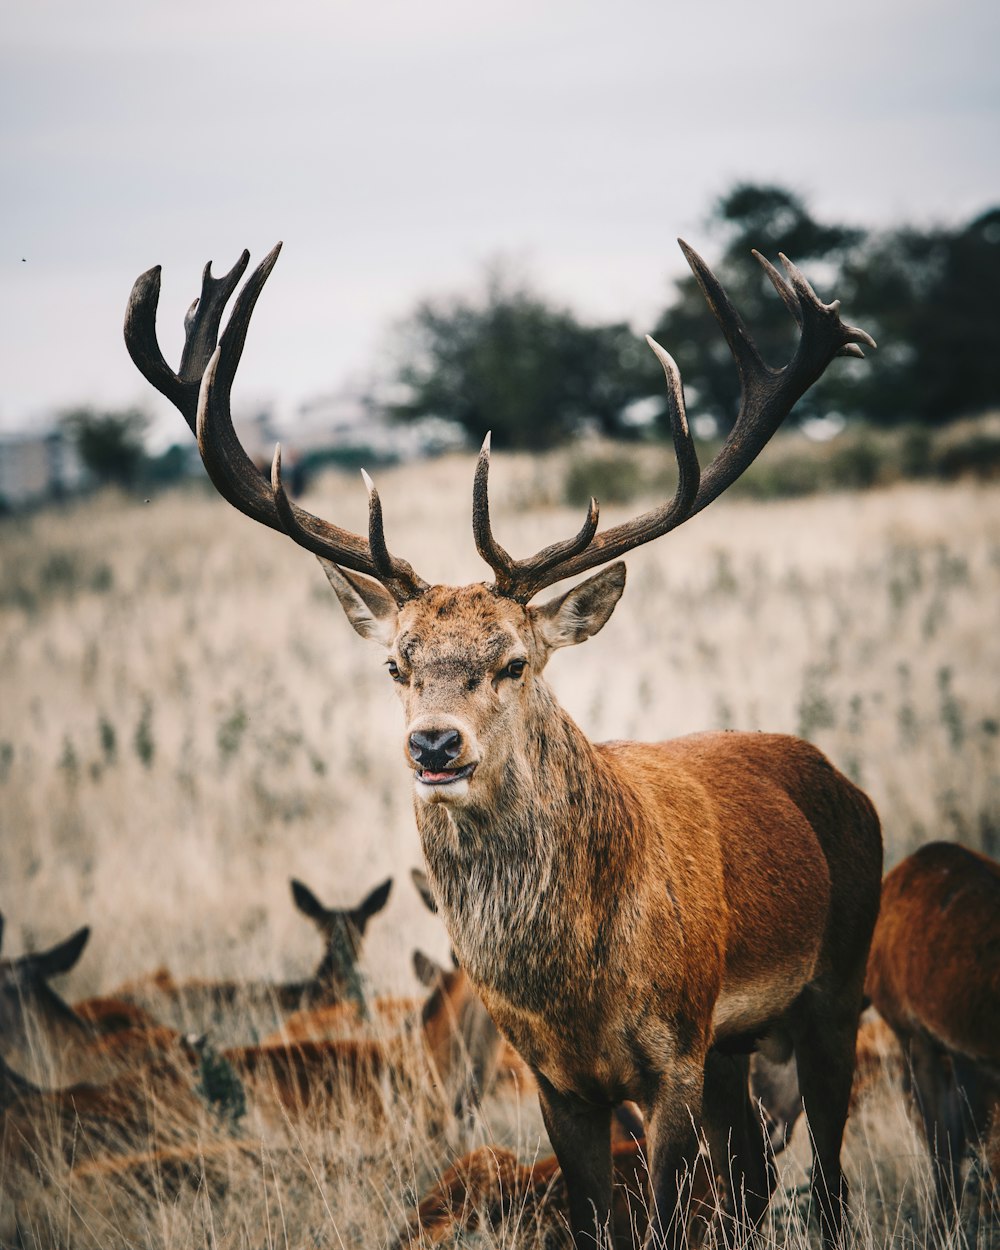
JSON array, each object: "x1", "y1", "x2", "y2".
[{"x1": 473, "y1": 240, "x2": 875, "y2": 604}]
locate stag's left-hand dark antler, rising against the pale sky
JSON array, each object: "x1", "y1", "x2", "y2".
[{"x1": 125, "y1": 243, "x2": 428, "y2": 604}]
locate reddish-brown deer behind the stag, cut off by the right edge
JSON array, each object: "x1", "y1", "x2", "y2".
[{"x1": 866, "y1": 843, "x2": 1000, "y2": 1223}]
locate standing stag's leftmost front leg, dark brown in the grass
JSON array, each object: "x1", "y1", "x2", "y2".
[{"x1": 535, "y1": 1071, "x2": 611, "y2": 1250}]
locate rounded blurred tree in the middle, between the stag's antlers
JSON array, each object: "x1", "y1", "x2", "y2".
[{"x1": 383, "y1": 271, "x2": 649, "y2": 450}]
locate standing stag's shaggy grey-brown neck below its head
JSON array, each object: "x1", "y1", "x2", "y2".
[{"x1": 416, "y1": 680, "x2": 643, "y2": 1010}]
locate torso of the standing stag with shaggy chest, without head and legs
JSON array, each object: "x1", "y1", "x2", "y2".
[{"x1": 418, "y1": 724, "x2": 880, "y2": 1106}]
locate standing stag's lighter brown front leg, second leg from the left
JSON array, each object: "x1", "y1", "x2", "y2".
[{"x1": 645, "y1": 1056, "x2": 705, "y2": 1250}]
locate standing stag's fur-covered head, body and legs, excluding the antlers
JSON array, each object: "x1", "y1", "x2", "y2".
[{"x1": 326, "y1": 577, "x2": 881, "y2": 1245}]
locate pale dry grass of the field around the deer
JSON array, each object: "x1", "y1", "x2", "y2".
[{"x1": 0, "y1": 458, "x2": 1000, "y2": 1250}]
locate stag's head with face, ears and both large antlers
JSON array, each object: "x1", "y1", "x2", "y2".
[{"x1": 125, "y1": 243, "x2": 874, "y2": 806}]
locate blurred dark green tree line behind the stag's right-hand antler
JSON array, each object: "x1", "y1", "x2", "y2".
[{"x1": 373, "y1": 184, "x2": 1000, "y2": 450}]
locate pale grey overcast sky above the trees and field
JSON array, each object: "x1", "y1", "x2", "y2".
[{"x1": 0, "y1": 0, "x2": 1000, "y2": 431}]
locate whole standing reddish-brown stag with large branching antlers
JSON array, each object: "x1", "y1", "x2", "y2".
[{"x1": 125, "y1": 244, "x2": 881, "y2": 1248}]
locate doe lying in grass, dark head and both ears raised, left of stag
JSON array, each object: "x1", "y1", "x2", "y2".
[{"x1": 115, "y1": 878, "x2": 393, "y2": 1024}]
